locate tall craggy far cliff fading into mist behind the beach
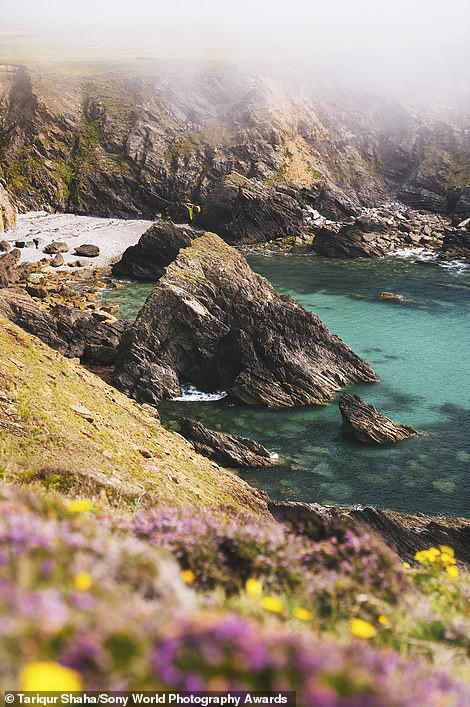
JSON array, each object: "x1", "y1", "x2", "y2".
[{"x1": 0, "y1": 61, "x2": 470, "y2": 241}]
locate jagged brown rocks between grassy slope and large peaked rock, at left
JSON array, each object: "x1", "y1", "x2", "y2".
[{"x1": 0, "y1": 290, "x2": 128, "y2": 365}]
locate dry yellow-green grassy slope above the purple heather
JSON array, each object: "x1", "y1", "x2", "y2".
[{"x1": 0, "y1": 319, "x2": 265, "y2": 512}]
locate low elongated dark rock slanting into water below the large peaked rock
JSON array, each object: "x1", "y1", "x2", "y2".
[{"x1": 180, "y1": 417, "x2": 277, "y2": 468}]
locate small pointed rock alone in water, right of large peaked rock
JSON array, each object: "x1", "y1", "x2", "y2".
[{"x1": 339, "y1": 394, "x2": 418, "y2": 444}]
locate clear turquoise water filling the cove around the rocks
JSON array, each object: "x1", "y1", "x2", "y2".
[{"x1": 107, "y1": 256, "x2": 470, "y2": 516}]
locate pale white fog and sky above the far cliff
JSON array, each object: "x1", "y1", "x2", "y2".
[{"x1": 0, "y1": 0, "x2": 470, "y2": 104}]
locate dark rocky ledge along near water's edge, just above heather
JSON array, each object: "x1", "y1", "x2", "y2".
[{"x1": 269, "y1": 501, "x2": 470, "y2": 566}]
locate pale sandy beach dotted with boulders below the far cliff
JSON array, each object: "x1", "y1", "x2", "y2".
[{"x1": 3, "y1": 211, "x2": 152, "y2": 267}]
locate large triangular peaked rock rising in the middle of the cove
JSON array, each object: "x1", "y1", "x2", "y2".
[{"x1": 114, "y1": 233, "x2": 377, "y2": 407}]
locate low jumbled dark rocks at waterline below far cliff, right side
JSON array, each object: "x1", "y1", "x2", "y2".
[{"x1": 313, "y1": 209, "x2": 448, "y2": 258}]
